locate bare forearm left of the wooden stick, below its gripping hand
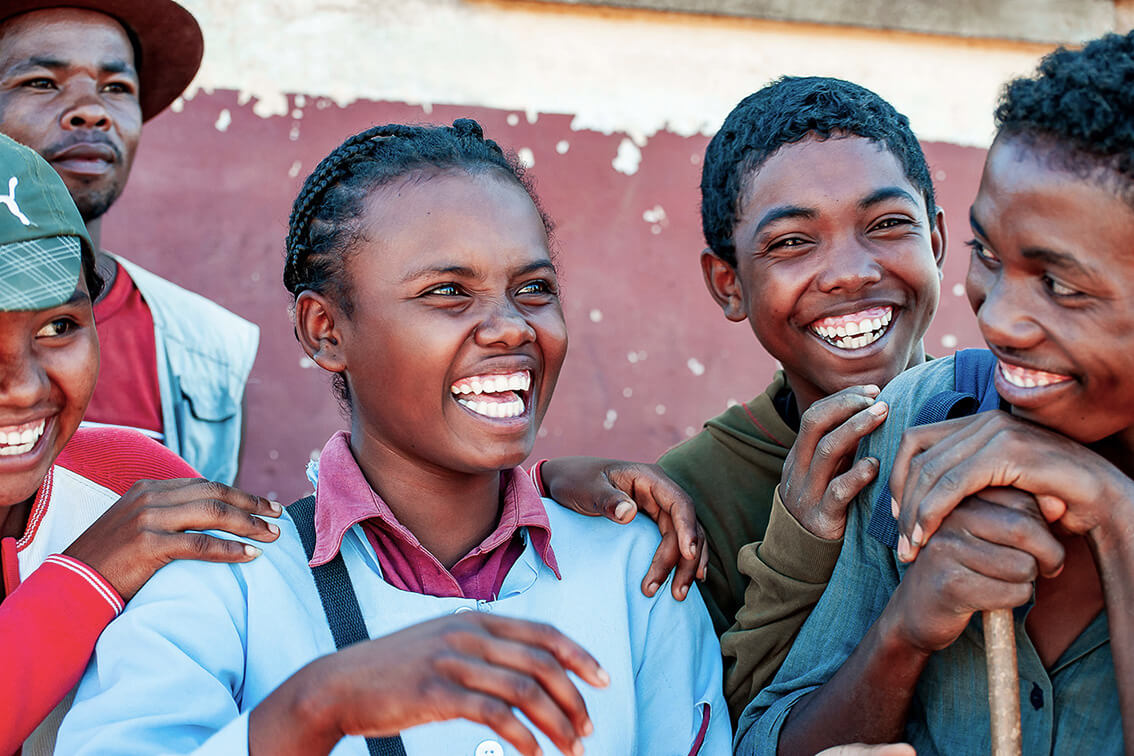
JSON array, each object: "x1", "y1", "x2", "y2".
[{"x1": 779, "y1": 601, "x2": 929, "y2": 754}]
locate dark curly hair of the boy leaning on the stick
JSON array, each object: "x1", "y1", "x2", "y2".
[{"x1": 996, "y1": 32, "x2": 1134, "y2": 205}]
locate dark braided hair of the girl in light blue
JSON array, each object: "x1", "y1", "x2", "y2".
[{"x1": 284, "y1": 118, "x2": 552, "y2": 407}]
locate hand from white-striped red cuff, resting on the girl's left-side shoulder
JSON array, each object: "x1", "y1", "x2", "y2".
[{"x1": 64, "y1": 478, "x2": 284, "y2": 601}]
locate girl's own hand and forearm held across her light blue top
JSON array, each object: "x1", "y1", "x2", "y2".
[{"x1": 248, "y1": 612, "x2": 610, "y2": 756}]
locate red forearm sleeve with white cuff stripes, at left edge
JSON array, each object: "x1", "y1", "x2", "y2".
[{"x1": 0, "y1": 557, "x2": 121, "y2": 754}]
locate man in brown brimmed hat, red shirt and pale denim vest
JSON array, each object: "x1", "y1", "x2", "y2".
[{"x1": 0, "y1": 0, "x2": 259, "y2": 483}]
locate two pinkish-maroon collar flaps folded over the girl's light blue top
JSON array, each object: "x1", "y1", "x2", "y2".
[{"x1": 310, "y1": 431, "x2": 560, "y2": 577}]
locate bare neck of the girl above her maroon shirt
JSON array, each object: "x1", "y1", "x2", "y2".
[{"x1": 350, "y1": 428, "x2": 501, "y2": 569}]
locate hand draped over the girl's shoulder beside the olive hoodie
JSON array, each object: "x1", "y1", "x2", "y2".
[{"x1": 540, "y1": 457, "x2": 709, "y2": 601}]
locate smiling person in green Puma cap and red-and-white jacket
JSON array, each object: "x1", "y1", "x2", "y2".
[{"x1": 0, "y1": 135, "x2": 281, "y2": 756}]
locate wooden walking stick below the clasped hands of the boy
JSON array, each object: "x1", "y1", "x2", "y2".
[{"x1": 981, "y1": 609, "x2": 1022, "y2": 756}]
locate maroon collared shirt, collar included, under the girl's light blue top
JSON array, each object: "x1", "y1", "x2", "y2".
[{"x1": 311, "y1": 431, "x2": 560, "y2": 601}]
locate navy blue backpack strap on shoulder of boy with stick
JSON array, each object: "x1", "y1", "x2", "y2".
[{"x1": 866, "y1": 349, "x2": 1000, "y2": 549}]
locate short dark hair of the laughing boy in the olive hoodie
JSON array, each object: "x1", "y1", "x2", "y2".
[{"x1": 701, "y1": 76, "x2": 937, "y2": 266}]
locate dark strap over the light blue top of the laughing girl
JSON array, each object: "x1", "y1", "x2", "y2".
[{"x1": 287, "y1": 496, "x2": 406, "y2": 756}]
